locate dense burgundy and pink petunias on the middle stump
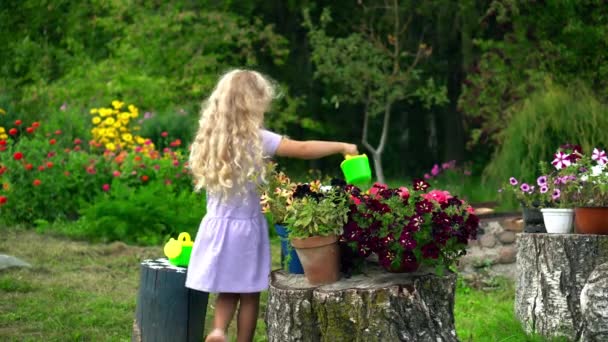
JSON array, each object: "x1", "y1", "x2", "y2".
[{"x1": 342, "y1": 180, "x2": 479, "y2": 272}]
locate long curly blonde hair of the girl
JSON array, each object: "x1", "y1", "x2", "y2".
[{"x1": 188, "y1": 69, "x2": 275, "y2": 199}]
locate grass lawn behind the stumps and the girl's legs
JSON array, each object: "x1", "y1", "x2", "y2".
[{"x1": 0, "y1": 228, "x2": 560, "y2": 341}]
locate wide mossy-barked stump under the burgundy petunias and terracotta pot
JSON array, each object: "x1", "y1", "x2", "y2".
[{"x1": 266, "y1": 264, "x2": 458, "y2": 342}]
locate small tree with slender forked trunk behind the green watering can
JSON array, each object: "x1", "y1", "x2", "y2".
[{"x1": 304, "y1": 0, "x2": 447, "y2": 182}]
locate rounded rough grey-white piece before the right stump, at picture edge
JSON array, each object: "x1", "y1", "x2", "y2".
[{"x1": 581, "y1": 263, "x2": 608, "y2": 341}]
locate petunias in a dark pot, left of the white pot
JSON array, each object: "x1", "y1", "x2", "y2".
[{"x1": 499, "y1": 176, "x2": 548, "y2": 233}]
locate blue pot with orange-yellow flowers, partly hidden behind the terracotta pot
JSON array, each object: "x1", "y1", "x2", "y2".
[{"x1": 260, "y1": 162, "x2": 304, "y2": 274}]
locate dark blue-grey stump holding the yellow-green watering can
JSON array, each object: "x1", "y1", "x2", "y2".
[{"x1": 131, "y1": 259, "x2": 208, "y2": 342}]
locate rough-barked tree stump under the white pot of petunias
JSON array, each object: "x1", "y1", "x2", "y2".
[{"x1": 515, "y1": 233, "x2": 608, "y2": 341}]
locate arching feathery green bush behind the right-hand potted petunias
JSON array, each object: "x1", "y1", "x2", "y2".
[{"x1": 484, "y1": 83, "x2": 608, "y2": 190}]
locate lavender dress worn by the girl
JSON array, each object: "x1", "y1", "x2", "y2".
[{"x1": 186, "y1": 130, "x2": 281, "y2": 293}]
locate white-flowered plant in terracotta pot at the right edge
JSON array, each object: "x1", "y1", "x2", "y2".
[{"x1": 569, "y1": 148, "x2": 608, "y2": 234}]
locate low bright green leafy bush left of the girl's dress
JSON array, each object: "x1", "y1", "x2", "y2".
[{"x1": 83, "y1": 181, "x2": 205, "y2": 245}]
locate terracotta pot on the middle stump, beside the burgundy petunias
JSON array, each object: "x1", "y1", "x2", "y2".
[{"x1": 291, "y1": 235, "x2": 340, "y2": 285}]
